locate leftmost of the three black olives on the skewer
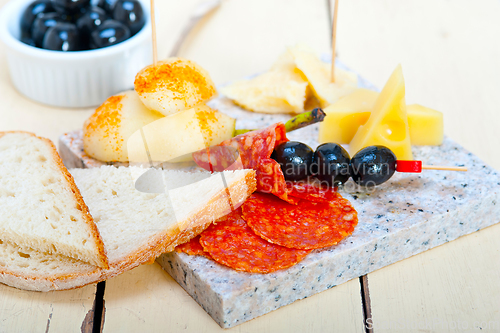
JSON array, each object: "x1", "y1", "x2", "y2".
[{"x1": 271, "y1": 141, "x2": 314, "y2": 180}]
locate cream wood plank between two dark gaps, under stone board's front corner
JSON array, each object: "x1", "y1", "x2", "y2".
[{"x1": 103, "y1": 263, "x2": 363, "y2": 333}]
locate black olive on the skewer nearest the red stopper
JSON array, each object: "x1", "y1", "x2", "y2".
[{"x1": 351, "y1": 146, "x2": 396, "y2": 186}]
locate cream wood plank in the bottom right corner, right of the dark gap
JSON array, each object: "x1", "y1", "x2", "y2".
[{"x1": 368, "y1": 223, "x2": 500, "y2": 333}]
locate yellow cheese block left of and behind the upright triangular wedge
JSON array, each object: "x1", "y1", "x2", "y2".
[{"x1": 318, "y1": 89, "x2": 379, "y2": 144}]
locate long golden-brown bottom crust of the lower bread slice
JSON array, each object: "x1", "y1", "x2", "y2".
[{"x1": 0, "y1": 170, "x2": 257, "y2": 292}]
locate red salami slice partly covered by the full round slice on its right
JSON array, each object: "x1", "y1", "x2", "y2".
[{"x1": 200, "y1": 208, "x2": 311, "y2": 273}]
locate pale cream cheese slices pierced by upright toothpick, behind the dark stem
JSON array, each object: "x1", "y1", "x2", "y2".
[{"x1": 222, "y1": 45, "x2": 357, "y2": 113}]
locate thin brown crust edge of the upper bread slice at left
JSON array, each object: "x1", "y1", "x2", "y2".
[{"x1": 0, "y1": 131, "x2": 109, "y2": 273}]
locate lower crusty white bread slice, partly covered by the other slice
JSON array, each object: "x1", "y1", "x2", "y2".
[{"x1": 0, "y1": 166, "x2": 256, "y2": 291}]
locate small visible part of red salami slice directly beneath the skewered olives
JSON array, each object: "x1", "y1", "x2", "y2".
[{"x1": 286, "y1": 181, "x2": 342, "y2": 202}]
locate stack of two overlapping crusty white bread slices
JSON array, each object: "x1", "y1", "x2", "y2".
[{"x1": 0, "y1": 132, "x2": 255, "y2": 291}]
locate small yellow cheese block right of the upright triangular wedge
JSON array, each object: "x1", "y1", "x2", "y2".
[{"x1": 406, "y1": 104, "x2": 444, "y2": 146}]
